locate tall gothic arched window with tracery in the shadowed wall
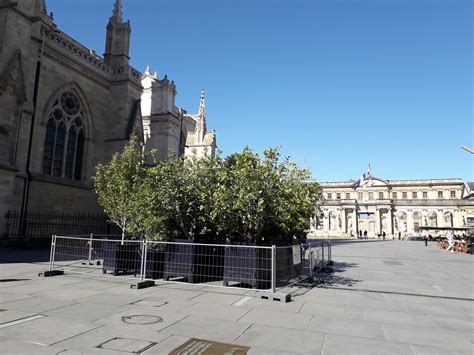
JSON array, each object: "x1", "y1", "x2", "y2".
[{"x1": 43, "y1": 91, "x2": 86, "y2": 180}]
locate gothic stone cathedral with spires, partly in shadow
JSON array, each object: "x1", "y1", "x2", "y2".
[{"x1": 0, "y1": 0, "x2": 216, "y2": 235}]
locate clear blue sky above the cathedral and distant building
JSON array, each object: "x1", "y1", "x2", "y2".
[{"x1": 47, "y1": 0, "x2": 474, "y2": 181}]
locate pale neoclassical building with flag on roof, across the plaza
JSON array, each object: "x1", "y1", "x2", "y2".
[{"x1": 310, "y1": 177, "x2": 474, "y2": 238}]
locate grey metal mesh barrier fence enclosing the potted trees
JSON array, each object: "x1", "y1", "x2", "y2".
[{"x1": 49, "y1": 234, "x2": 331, "y2": 292}]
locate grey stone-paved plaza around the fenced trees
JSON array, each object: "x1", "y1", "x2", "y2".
[{"x1": 0, "y1": 240, "x2": 474, "y2": 354}]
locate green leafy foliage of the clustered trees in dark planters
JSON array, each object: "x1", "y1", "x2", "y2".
[{"x1": 94, "y1": 139, "x2": 322, "y2": 243}]
